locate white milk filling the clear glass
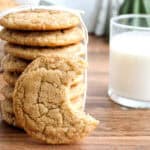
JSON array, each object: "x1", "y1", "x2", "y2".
[{"x1": 109, "y1": 31, "x2": 150, "y2": 101}]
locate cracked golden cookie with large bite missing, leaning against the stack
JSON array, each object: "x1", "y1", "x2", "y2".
[{"x1": 13, "y1": 57, "x2": 98, "y2": 144}]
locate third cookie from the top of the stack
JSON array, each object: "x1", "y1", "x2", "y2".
[{"x1": 4, "y1": 43, "x2": 84, "y2": 60}]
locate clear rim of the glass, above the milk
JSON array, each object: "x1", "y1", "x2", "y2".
[{"x1": 110, "y1": 14, "x2": 150, "y2": 30}]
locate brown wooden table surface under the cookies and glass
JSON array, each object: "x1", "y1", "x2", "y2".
[{"x1": 0, "y1": 36, "x2": 150, "y2": 150}]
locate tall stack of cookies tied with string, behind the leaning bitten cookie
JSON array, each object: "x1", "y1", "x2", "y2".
[{"x1": 0, "y1": 10, "x2": 85, "y2": 124}]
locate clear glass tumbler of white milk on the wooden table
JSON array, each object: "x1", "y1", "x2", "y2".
[{"x1": 108, "y1": 15, "x2": 150, "y2": 108}]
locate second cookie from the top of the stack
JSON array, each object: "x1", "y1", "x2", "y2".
[{"x1": 0, "y1": 27, "x2": 84, "y2": 47}]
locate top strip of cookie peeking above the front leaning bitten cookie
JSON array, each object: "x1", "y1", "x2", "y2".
[{"x1": 21, "y1": 55, "x2": 87, "y2": 75}]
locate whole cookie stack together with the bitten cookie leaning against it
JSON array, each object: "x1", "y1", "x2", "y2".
[{"x1": 0, "y1": 9, "x2": 98, "y2": 144}]
